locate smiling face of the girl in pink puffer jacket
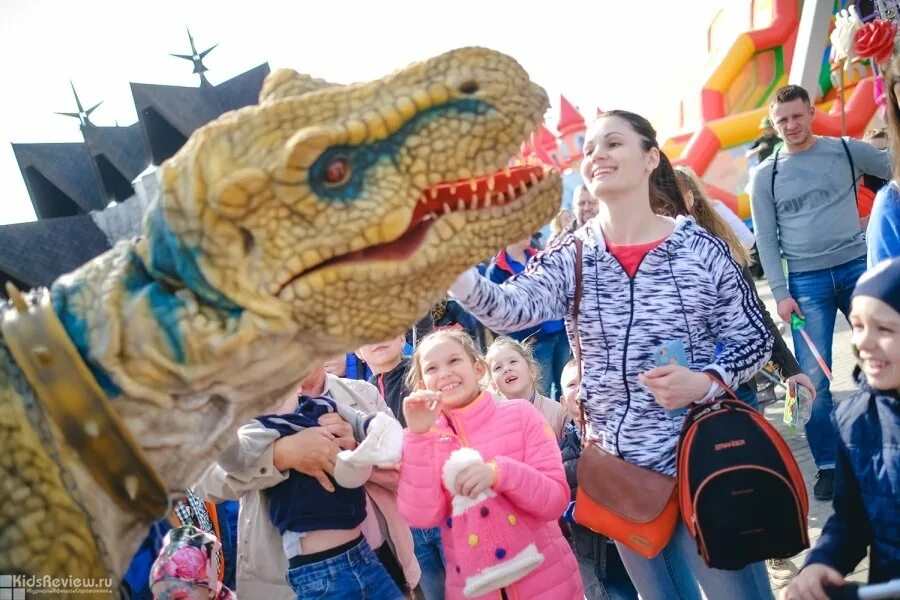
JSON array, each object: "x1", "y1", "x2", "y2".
[{"x1": 419, "y1": 338, "x2": 484, "y2": 408}]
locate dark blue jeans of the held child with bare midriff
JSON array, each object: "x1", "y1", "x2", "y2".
[{"x1": 287, "y1": 540, "x2": 404, "y2": 600}]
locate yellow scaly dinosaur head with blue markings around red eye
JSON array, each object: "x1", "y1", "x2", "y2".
[{"x1": 146, "y1": 48, "x2": 561, "y2": 349}]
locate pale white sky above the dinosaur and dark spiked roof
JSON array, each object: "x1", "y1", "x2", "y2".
[{"x1": 0, "y1": 0, "x2": 716, "y2": 224}]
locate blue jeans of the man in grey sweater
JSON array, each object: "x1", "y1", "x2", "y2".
[{"x1": 788, "y1": 256, "x2": 866, "y2": 469}]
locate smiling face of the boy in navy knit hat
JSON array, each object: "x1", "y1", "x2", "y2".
[{"x1": 850, "y1": 296, "x2": 900, "y2": 390}]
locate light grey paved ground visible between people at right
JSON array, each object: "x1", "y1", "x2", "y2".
[{"x1": 757, "y1": 280, "x2": 869, "y2": 595}]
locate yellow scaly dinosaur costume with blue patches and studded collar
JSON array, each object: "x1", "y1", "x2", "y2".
[{"x1": 0, "y1": 48, "x2": 561, "y2": 597}]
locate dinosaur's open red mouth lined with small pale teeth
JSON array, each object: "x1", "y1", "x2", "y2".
[{"x1": 277, "y1": 165, "x2": 559, "y2": 297}]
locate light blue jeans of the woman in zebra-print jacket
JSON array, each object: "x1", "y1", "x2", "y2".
[{"x1": 616, "y1": 519, "x2": 775, "y2": 600}]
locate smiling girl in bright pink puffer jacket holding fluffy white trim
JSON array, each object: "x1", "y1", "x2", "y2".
[{"x1": 397, "y1": 330, "x2": 584, "y2": 600}]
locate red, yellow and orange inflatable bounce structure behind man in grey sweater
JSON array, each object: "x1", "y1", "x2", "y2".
[{"x1": 663, "y1": 0, "x2": 882, "y2": 219}]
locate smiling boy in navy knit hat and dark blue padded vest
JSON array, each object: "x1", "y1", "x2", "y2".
[{"x1": 785, "y1": 259, "x2": 900, "y2": 600}]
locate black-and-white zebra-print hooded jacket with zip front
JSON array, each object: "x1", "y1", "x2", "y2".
[{"x1": 451, "y1": 217, "x2": 773, "y2": 475}]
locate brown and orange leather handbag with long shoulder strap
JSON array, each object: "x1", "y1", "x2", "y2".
[{"x1": 572, "y1": 238, "x2": 678, "y2": 558}]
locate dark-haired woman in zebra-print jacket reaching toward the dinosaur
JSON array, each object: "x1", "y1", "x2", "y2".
[{"x1": 451, "y1": 111, "x2": 777, "y2": 600}]
